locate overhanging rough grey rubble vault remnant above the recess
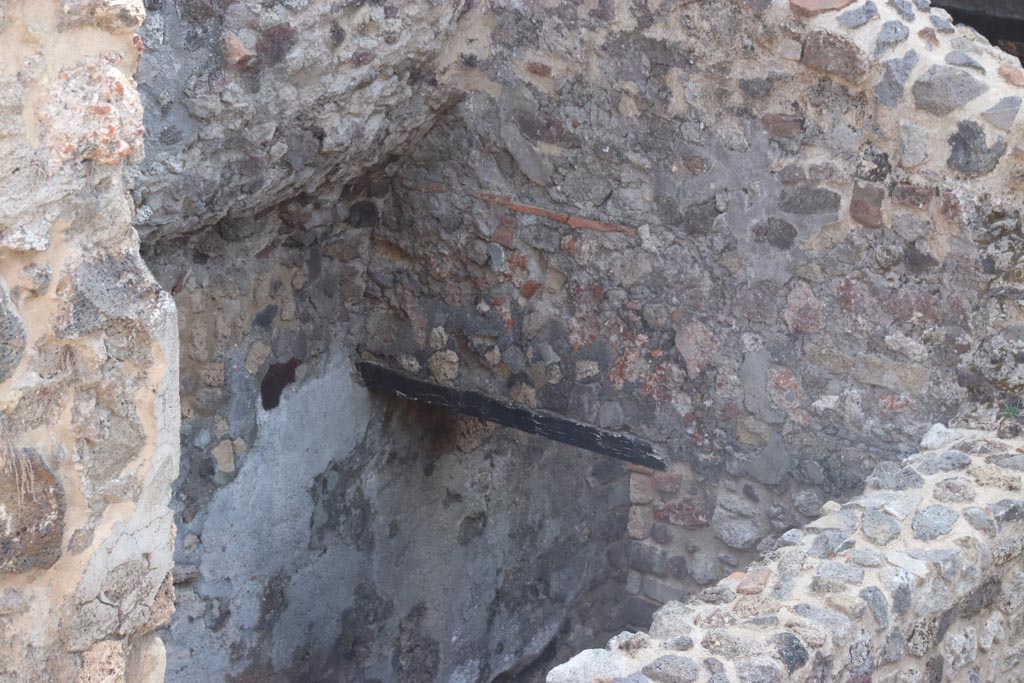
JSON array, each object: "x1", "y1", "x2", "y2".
[{"x1": 135, "y1": 0, "x2": 472, "y2": 238}]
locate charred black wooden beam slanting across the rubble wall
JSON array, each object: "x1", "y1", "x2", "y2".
[{"x1": 358, "y1": 361, "x2": 669, "y2": 470}]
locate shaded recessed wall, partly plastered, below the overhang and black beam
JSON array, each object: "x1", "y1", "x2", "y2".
[{"x1": 137, "y1": 188, "x2": 628, "y2": 683}]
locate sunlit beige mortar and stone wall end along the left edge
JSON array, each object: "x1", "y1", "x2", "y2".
[{"x1": 0, "y1": 0, "x2": 178, "y2": 683}]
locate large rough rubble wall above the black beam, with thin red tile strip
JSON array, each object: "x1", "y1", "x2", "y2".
[{"x1": 364, "y1": 0, "x2": 1024, "y2": 615}]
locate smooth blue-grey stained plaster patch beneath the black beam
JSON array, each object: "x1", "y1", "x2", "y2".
[{"x1": 158, "y1": 347, "x2": 627, "y2": 683}]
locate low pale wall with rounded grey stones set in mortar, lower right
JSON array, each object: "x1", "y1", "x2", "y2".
[{"x1": 548, "y1": 425, "x2": 1024, "y2": 683}]
